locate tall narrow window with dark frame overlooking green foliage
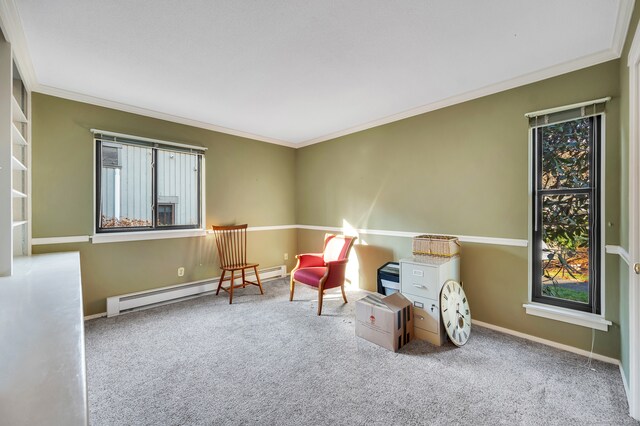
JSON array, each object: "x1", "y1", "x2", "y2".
[{"x1": 531, "y1": 111, "x2": 603, "y2": 314}]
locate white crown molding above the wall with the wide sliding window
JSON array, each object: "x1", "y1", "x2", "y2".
[{"x1": 33, "y1": 84, "x2": 297, "y2": 148}]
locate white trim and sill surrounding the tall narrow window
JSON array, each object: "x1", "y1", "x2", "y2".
[{"x1": 522, "y1": 110, "x2": 612, "y2": 331}]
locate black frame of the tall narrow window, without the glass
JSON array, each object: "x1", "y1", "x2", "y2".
[{"x1": 529, "y1": 112, "x2": 605, "y2": 317}]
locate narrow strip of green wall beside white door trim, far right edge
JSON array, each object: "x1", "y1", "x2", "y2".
[{"x1": 619, "y1": 0, "x2": 640, "y2": 383}]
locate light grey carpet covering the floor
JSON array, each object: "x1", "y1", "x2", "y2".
[{"x1": 86, "y1": 279, "x2": 636, "y2": 425}]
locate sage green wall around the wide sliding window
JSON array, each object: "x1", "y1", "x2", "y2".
[{"x1": 32, "y1": 93, "x2": 297, "y2": 315}]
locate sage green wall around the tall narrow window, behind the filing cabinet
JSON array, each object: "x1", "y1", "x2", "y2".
[{"x1": 296, "y1": 60, "x2": 621, "y2": 358}]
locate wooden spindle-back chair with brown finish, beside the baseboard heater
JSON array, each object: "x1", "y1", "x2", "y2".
[{"x1": 212, "y1": 224, "x2": 264, "y2": 304}]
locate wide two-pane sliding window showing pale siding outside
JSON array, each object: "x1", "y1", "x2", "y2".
[{"x1": 94, "y1": 131, "x2": 203, "y2": 233}]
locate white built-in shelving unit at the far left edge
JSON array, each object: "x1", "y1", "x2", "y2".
[{"x1": 0, "y1": 36, "x2": 31, "y2": 276}]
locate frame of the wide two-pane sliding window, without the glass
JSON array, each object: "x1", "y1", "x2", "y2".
[{"x1": 92, "y1": 135, "x2": 206, "y2": 235}]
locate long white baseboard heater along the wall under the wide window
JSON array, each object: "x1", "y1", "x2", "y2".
[{"x1": 107, "y1": 265, "x2": 287, "y2": 317}]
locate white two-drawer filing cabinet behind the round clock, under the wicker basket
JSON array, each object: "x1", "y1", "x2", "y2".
[{"x1": 400, "y1": 256, "x2": 460, "y2": 346}]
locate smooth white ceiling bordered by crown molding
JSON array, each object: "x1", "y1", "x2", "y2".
[{"x1": 8, "y1": 0, "x2": 633, "y2": 146}]
